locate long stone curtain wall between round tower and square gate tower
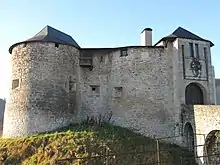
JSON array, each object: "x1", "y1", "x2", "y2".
[{"x1": 80, "y1": 47, "x2": 175, "y2": 137}]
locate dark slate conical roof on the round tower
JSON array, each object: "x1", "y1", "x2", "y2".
[{"x1": 9, "y1": 25, "x2": 80, "y2": 53}]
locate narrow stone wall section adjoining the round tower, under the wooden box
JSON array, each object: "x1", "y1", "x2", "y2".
[{"x1": 79, "y1": 49, "x2": 114, "y2": 118}]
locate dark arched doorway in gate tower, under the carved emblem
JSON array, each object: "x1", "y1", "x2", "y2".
[{"x1": 185, "y1": 83, "x2": 204, "y2": 105}]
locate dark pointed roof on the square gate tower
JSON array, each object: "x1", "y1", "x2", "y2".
[{"x1": 155, "y1": 27, "x2": 214, "y2": 47}]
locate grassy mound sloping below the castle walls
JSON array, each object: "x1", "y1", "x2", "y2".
[{"x1": 0, "y1": 124, "x2": 195, "y2": 165}]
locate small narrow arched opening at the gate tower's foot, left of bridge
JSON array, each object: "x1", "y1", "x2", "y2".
[{"x1": 184, "y1": 123, "x2": 194, "y2": 152}]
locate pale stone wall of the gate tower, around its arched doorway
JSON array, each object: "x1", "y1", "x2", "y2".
[{"x1": 174, "y1": 39, "x2": 215, "y2": 106}]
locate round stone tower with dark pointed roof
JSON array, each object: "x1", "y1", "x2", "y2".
[{"x1": 3, "y1": 26, "x2": 80, "y2": 137}]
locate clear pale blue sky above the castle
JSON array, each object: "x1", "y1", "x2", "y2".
[{"x1": 0, "y1": 0, "x2": 220, "y2": 98}]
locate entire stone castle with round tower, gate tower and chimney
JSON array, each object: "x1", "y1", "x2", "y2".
[{"x1": 3, "y1": 26, "x2": 220, "y2": 164}]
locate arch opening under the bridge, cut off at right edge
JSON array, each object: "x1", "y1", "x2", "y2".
[{"x1": 204, "y1": 130, "x2": 220, "y2": 164}]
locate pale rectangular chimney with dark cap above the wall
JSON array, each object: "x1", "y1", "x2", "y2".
[{"x1": 141, "y1": 28, "x2": 152, "y2": 46}]
